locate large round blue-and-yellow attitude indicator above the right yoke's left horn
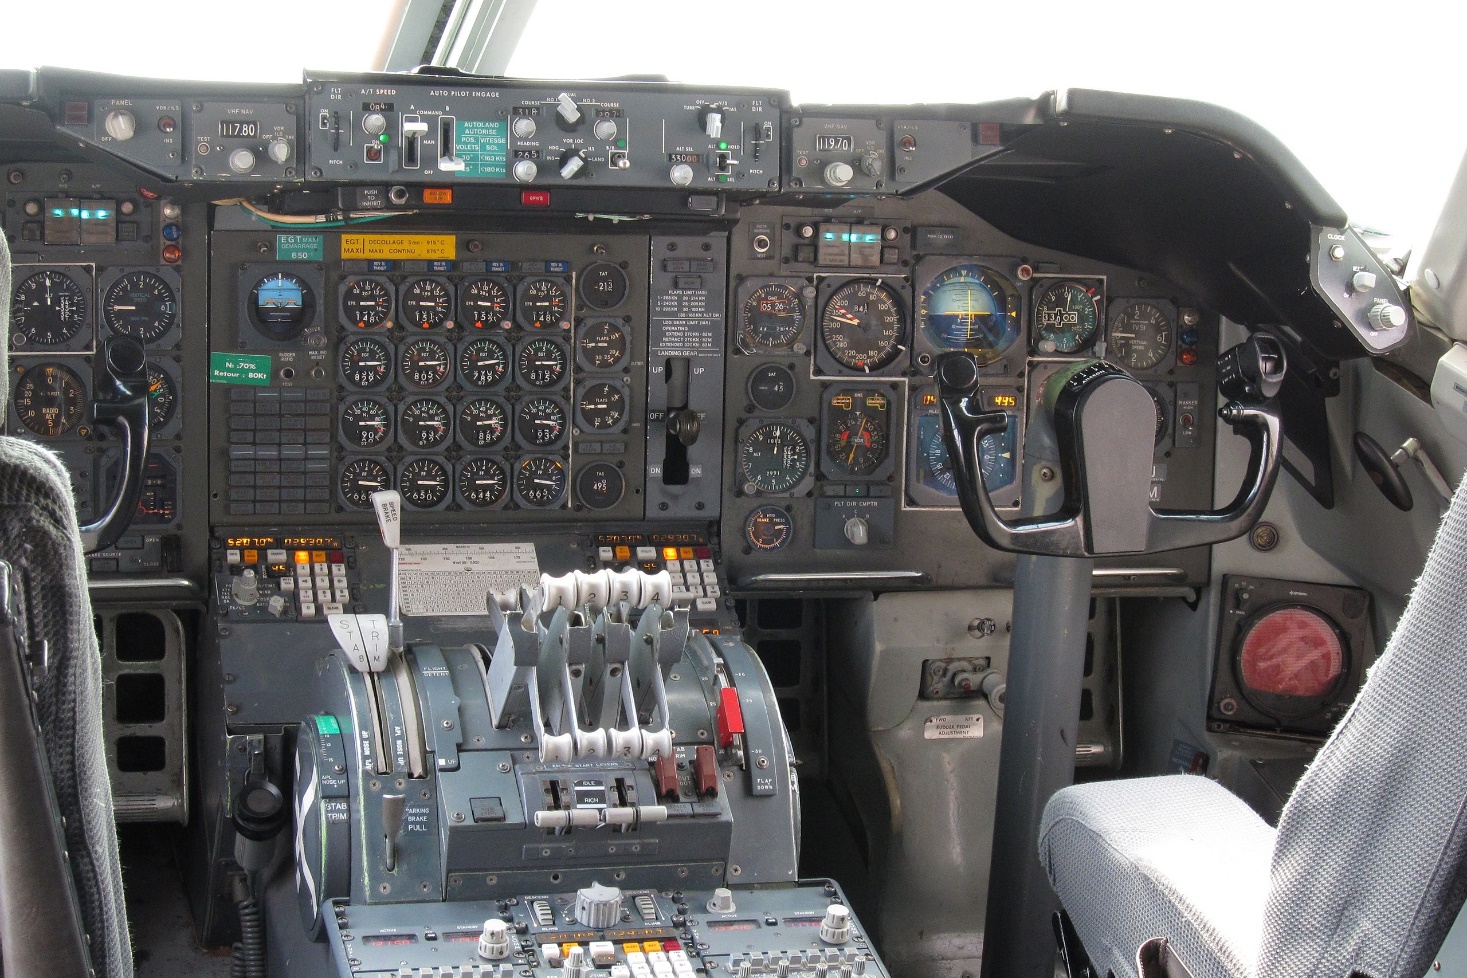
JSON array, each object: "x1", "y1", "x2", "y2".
[{"x1": 917, "y1": 265, "x2": 1020, "y2": 364}]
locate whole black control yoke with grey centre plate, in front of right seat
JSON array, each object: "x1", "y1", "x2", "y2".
[{"x1": 937, "y1": 333, "x2": 1285, "y2": 557}]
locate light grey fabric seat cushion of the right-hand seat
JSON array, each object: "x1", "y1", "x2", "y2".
[{"x1": 1039, "y1": 774, "x2": 1275, "y2": 978}]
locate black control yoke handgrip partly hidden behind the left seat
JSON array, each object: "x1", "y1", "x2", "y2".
[{"x1": 81, "y1": 336, "x2": 148, "y2": 553}]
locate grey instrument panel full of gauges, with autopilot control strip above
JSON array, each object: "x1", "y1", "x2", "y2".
[{"x1": 6, "y1": 74, "x2": 1218, "y2": 589}]
